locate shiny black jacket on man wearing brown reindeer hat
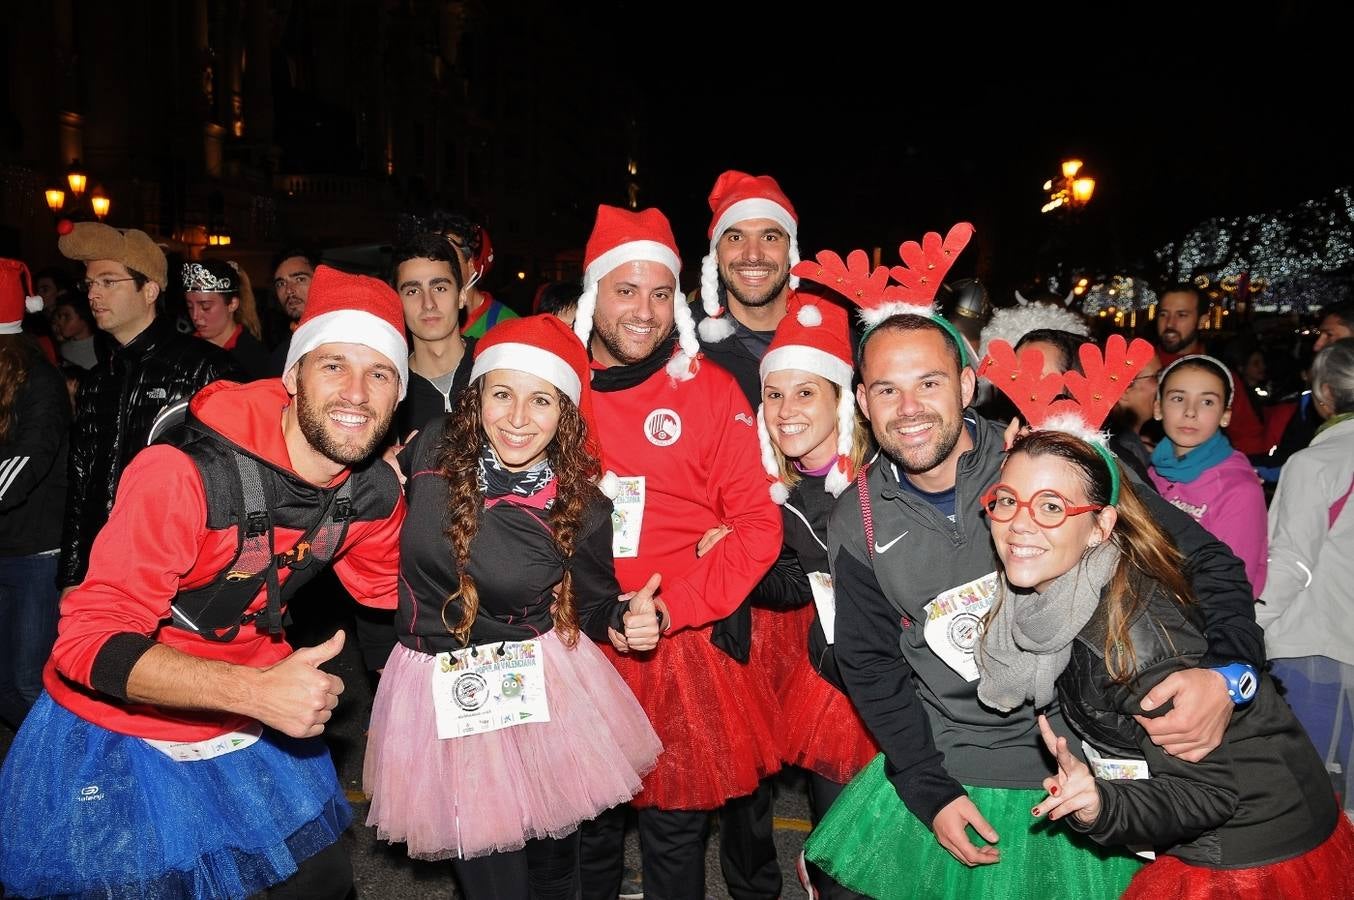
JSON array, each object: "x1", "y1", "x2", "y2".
[{"x1": 57, "y1": 317, "x2": 244, "y2": 587}]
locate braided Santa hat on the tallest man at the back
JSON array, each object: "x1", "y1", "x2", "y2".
[{"x1": 700, "y1": 169, "x2": 799, "y2": 344}]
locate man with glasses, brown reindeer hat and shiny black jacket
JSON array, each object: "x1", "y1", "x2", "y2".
[{"x1": 57, "y1": 222, "x2": 240, "y2": 589}]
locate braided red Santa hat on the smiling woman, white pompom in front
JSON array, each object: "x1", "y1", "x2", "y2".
[{"x1": 757, "y1": 294, "x2": 856, "y2": 503}]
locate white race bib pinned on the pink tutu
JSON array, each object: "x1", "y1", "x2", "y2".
[{"x1": 432, "y1": 640, "x2": 550, "y2": 740}]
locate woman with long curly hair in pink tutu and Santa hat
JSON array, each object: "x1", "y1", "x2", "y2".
[{"x1": 363, "y1": 315, "x2": 661, "y2": 899}]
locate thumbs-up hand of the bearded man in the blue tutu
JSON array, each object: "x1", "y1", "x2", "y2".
[{"x1": 249, "y1": 631, "x2": 344, "y2": 738}]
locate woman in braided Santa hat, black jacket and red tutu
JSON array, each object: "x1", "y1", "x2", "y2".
[{"x1": 753, "y1": 294, "x2": 879, "y2": 897}]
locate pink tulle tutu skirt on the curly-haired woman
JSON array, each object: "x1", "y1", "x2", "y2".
[{"x1": 362, "y1": 631, "x2": 662, "y2": 859}]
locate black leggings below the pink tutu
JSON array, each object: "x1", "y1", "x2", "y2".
[{"x1": 451, "y1": 831, "x2": 578, "y2": 900}]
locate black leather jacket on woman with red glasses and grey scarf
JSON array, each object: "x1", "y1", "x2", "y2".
[{"x1": 1057, "y1": 583, "x2": 1339, "y2": 869}]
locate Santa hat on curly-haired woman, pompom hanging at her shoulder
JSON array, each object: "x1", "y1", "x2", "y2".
[{"x1": 470, "y1": 313, "x2": 617, "y2": 497}]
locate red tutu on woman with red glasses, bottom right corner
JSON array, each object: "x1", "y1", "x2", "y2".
[{"x1": 1124, "y1": 812, "x2": 1354, "y2": 900}]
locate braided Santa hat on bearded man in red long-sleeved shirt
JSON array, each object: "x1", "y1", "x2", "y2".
[{"x1": 568, "y1": 206, "x2": 700, "y2": 382}]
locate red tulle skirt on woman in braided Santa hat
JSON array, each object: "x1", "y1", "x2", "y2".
[{"x1": 780, "y1": 652, "x2": 879, "y2": 785}]
